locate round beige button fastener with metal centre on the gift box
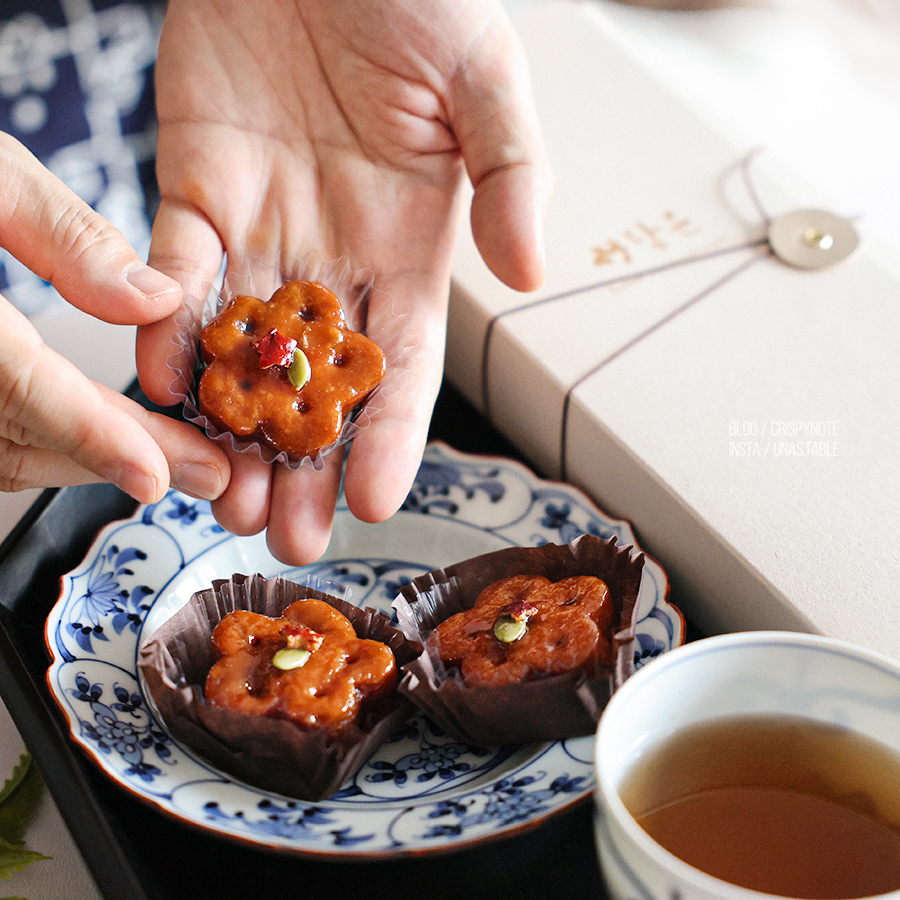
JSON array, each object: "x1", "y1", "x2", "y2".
[{"x1": 769, "y1": 209, "x2": 859, "y2": 269}]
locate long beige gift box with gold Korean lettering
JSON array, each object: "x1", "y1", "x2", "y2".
[{"x1": 447, "y1": 0, "x2": 900, "y2": 657}]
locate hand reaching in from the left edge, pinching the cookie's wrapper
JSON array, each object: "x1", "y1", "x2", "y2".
[{"x1": 0, "y1": 134, "x2": 229, "y2": 503}]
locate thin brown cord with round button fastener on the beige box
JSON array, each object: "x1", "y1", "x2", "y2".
[{"x1": 481, "y1": 151, "x2": 858, "y2": 480}]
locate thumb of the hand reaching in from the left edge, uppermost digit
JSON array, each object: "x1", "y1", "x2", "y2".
[{"x1": 0, "y1": 134, "x2": 181, "y2": 325}]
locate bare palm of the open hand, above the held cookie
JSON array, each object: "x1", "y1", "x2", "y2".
[{"x1": 151, "y1": 0, "x2": 488, "y2": 290}]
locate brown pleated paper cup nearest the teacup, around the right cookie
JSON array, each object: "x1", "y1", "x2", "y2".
[{"x1": 393, "y1": 535, "x2": 644, "y2": 747}]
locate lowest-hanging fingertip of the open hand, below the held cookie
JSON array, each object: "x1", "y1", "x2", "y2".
[{"x1": 266, "y1": 448, "x2": 343, "y2": 566}]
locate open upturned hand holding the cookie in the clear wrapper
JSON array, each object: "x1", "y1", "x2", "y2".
[{"x1": 138, "y1": 0, "x2": 552, "y2": 565}]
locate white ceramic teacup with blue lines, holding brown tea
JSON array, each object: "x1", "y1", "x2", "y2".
[{"x1": 594, "y1": 632, "x2": 900, "y2": 900}]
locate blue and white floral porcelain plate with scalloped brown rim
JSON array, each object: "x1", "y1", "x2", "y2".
[{"x1": 46, "y1": 444, "x2": 684, "y2": 858}]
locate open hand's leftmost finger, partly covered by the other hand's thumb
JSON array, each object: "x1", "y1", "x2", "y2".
[{"x1": 135, "y1": 201, "x2": 229, "y2": 406}]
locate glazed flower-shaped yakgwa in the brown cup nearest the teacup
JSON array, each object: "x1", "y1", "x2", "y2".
[{"x1": 429, "y1": 575, "x2": 615, "y2": 685}]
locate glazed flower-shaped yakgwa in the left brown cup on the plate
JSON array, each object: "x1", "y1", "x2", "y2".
[{"x1": 205, "y1": 598, "x2": 397, "y2": 731}]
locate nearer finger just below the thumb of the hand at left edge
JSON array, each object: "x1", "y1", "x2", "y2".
[{"x1": 0, "y1": 302, "x2": 169, "y2": 503}]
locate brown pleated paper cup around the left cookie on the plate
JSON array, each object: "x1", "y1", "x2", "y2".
[{"x1": 139, "y1": 575, "x2": 421, "y2": 801}]
